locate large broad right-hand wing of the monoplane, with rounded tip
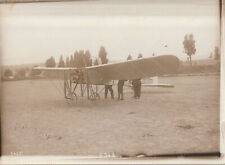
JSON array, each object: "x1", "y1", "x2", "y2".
[{"x1": 86, "y1": 55, "x2": 179, "y2": 84}]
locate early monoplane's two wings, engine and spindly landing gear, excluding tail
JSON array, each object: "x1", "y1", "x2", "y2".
[{"x1": 34, "y1": 55, "x2": 179, "y2": 100}]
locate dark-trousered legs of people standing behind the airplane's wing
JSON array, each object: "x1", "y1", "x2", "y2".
[{"x1": 105, "y1": 79, "x2": 141, "y2": 100}]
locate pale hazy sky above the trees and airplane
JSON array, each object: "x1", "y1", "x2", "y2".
[{"x1": 0, "y1": 0, "x2": 220, "y2": 65}]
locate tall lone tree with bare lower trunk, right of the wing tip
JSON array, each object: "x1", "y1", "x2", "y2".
[{"x1": 183, "y1": 34, "x2": 196, "y2": 66}]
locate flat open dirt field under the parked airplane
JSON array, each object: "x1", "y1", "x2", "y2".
[{"x1": 1, "y1": 76, "x2": 219, "y2": 156}]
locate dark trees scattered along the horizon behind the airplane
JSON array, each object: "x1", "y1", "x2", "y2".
[{"x1": 2, "y1": 34, "x2": 220, "y2": 79}]
